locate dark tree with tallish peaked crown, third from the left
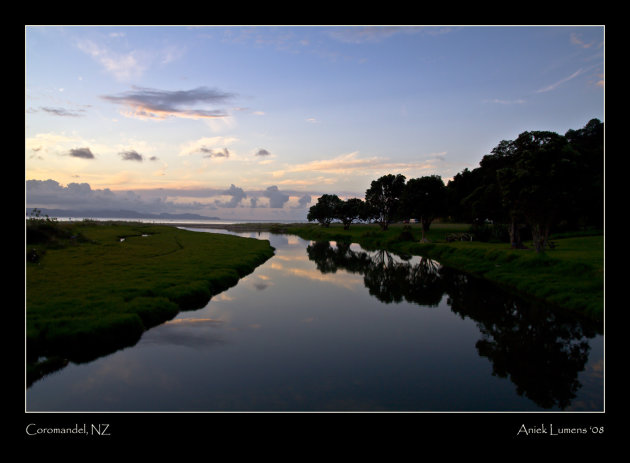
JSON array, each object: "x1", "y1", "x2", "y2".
[{"x1": 365, "y1": 174, "x2": 405, "y2": 230}]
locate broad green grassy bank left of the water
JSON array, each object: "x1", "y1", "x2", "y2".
[{"x1": 26, "y1": 221, "x2": 273, "y2": 384}]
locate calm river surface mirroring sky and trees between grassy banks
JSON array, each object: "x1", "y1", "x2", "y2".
[{"x1": 27, "y1": 230, "x2": 604, "y2": 411}]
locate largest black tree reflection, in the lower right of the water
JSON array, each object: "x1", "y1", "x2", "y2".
[{"x1": 442, "y1": 269, "x2": 597, "y2": 409}]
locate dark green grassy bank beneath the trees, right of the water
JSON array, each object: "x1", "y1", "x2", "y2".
[{"x1": 283, "y1": 224, "x2": 604, "y2": 321}]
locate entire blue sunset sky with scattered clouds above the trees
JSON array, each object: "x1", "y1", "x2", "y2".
[{"x1": 25, "y1": 25, "x2": 605, "y2": 220}]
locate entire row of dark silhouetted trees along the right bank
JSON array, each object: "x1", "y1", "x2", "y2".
[{"x1": 307, "y1": 119, "x2": 604, "y2": 252}]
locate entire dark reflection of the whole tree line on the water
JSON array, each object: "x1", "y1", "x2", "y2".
[{"x1": 306, "y1": 241, "x2": 601, "y2": 410}]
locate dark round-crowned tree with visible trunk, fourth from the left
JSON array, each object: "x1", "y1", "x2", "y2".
[{"x1": 402, "y1": 175, "x2": 447, "y2": 242}]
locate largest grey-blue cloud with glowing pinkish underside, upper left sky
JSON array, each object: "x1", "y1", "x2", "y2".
[{"x1": 102, "y1": 87, "x2": 234, "y2": 120}]
